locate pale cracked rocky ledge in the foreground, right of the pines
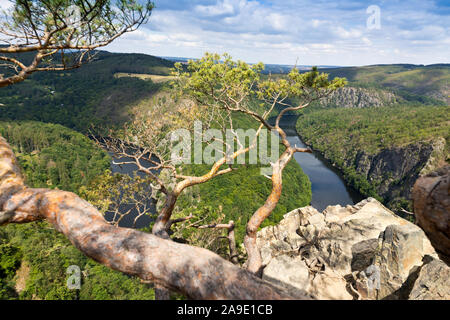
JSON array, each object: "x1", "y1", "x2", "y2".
[{"x1": 257, "y1": 198, "x2": 450, "y2": 300}]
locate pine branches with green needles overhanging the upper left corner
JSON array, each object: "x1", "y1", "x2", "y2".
[{"x1": 0, "y1": 0, "x2": 154, "y2": 87}]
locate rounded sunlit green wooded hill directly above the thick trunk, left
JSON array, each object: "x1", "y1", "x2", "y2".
[{"x1": 0, "y1": 121, "x2": 110, "y2": 192}]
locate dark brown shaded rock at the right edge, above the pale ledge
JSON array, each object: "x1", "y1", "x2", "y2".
[{"x1": 413, "y1": 166, "x2": 450, "y2": 263}]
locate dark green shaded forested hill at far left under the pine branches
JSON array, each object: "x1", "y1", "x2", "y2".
[{"x1": 0, "y1": 52, "x2": 173, "y2": 132}]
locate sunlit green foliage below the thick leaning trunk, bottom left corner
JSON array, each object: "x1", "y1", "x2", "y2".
[{"x1": 0, "y1": 222, "x2": 153, "y2": 300}]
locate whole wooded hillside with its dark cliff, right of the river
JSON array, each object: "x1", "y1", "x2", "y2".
[{"x1": 297, "y1": 105, "x2": 450, "y2": 208}]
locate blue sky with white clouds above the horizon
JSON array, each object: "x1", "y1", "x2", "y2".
[{"x1": 103, "y1": 0, "x2": 450, "y2": 65}]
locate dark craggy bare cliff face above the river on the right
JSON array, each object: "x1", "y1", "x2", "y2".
[{"x1": 346, "y1": 138, "x2": 446, "y2": 207}]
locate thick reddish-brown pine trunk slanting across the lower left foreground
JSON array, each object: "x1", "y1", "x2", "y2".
[{"x1": 0, "y1": 136, "x2": 310, "y2": 300}]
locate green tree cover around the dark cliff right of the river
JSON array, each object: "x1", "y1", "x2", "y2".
[{"x1": 297, "y1": 105, "x2": 450, "y2": 199}]
